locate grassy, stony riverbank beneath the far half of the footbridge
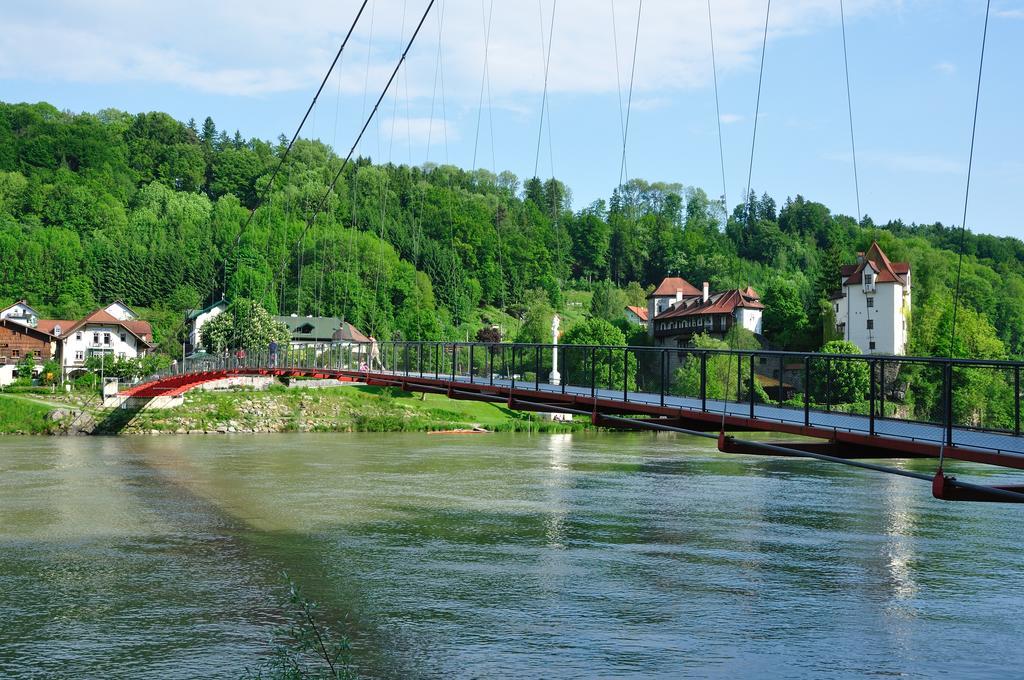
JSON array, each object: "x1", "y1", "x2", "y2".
[{"x1": 111, "y1": 385, "x2": 587, "y2": 434}]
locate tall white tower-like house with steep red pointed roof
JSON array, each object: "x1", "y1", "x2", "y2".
[{"x1": 831, "y1": 242, "x2": 910, "y2": 354}]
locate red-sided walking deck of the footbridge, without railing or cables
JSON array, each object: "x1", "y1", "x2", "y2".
[{"x1": 123, "y1": 367, "x2": 1024, "y2": 469}]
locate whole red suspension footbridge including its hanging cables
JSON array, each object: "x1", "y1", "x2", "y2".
[{"x1": 136, "y1": 0, "x2": 1024, "y2": 503}]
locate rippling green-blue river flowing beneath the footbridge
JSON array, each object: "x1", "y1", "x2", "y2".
[{"x1": 0, "y1": 433, "x2": 1024, "y2": 678}]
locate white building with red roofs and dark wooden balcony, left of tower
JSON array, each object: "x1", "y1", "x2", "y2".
[{"x1": 647, "y1": 278, "x2": 764, "y2": 346}]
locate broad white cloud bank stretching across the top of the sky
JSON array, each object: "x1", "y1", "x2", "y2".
[{"x1": 0, "y1": 0, "x2": 899, "y2": 99}]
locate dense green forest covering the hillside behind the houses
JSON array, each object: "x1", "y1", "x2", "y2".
[{"x1": 0, "y1": 103, "x2": 1024, "y2": 357}]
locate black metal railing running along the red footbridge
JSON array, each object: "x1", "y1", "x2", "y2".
[{"x1": 140, "y1": 341, "x2": 1024, "y2": 444}]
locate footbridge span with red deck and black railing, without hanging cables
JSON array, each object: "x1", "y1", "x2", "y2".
[{"x1": 122, "y1": 342, "x2": 1024, "y2": 503}]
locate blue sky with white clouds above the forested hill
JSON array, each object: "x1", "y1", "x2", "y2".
[{"x1": 0, "y1": 0, "x2": 1024, "y2": 238}]
